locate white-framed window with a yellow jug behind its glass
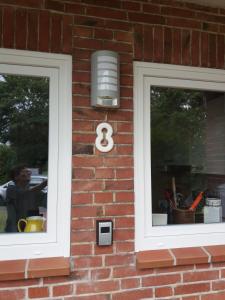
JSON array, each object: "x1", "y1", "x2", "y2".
[{"x1": 0, "y1": 49, "x2": 72, "y2": 260}]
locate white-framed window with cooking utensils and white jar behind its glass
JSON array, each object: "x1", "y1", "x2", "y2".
[{"x1": 134, "y1": 62, "x2": 225, "y2": 251}]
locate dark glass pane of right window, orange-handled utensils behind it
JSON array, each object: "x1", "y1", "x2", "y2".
[{"x1": 151, "y1": 86, "x2": 225, "y2": 225}]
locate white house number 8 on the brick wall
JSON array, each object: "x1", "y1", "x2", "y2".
[{"x1": 95, "y1": 123, "x2": 114, "y2": 152}]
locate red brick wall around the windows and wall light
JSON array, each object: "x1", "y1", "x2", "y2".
[{"x1": 0, "y1": 0, "x2": 225, "y2": 300}]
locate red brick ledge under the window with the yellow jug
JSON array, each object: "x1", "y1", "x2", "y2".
[{"x1": 0, "y1": 257, "x2": 70, "y2": 281}]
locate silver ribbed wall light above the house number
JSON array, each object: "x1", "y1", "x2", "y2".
[{"x1": 91, "y1": 50, "x2": 120, "y2": 108}]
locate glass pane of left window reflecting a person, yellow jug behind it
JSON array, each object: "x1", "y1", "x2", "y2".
[{"x1": 0, "y1": 74, "x2": 49, "y2": 233}]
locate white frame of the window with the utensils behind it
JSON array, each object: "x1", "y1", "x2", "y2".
[{"x1": 134, "y1": 62, "x2": 225, "y2": 251}]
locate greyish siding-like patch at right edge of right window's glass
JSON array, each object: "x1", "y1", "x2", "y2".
[{"x1": 206, "y1": 96, "x2": 225, "y2": 175}]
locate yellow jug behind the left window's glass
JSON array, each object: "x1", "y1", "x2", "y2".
[{"x1": 17, "y1": 216, "x2": 45, "y2": 232}]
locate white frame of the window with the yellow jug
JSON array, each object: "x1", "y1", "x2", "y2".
[{"x1": 0, "y1": 48, "x2": 72, "y2": 260}]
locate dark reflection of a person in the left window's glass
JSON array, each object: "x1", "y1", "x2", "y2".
[{"x1": 5, "y1": 166, "x2": 47, "y2": 232}]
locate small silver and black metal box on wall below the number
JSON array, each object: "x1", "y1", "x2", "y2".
[{"x1": 96, "y1": 220, "x2": 113, "y2": 246}]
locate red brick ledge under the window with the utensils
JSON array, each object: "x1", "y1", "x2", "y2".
[{"x1": 136, "y1": 245, "x2": 225, "y2": 269}]
